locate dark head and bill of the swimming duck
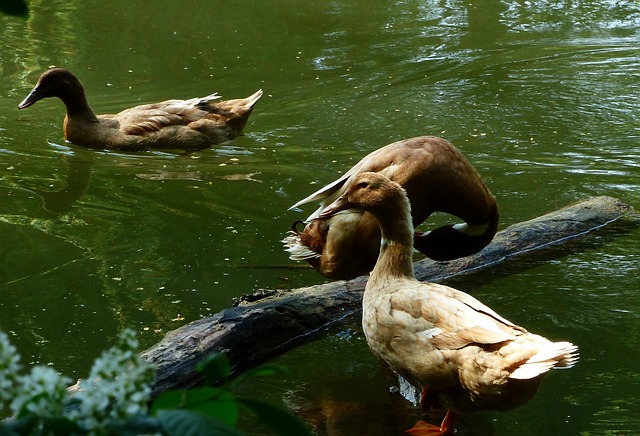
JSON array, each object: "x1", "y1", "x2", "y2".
[{"x1": 18, "y1": 68, "x2": 84, "y2": 109}]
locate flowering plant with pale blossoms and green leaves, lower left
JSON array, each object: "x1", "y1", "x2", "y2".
[{"x1": 0, "y1": 329, "x2": 310, "y2": 436}]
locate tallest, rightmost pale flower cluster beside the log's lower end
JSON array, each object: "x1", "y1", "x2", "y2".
[{"x1": 72, "y1": 329, "x2": 154, "y2": 432}]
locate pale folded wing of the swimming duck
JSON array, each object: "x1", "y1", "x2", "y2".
[{"x1": 114, "y1": 94, "x2": 219, "y2": 135}]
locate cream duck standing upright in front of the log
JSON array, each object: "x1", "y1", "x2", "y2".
[{"x1": 319, "y1": 172, "x2": 578, "y2": 435}]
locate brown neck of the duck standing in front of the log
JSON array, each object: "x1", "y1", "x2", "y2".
[{"x1": 369, "y1": 196, "x2": 415, "y2": 283}]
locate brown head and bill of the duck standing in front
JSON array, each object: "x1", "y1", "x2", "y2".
[{"x1": 319, "y1": 172, "x2": 408, "y2": 218}]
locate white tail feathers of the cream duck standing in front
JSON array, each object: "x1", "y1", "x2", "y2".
[{"x1": 509, "y1": 342, "x2": 580, "y2": 380}]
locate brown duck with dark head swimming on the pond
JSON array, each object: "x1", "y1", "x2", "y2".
[{"x1": 18, "y1": 68, "x2": 262, "y2": 150}]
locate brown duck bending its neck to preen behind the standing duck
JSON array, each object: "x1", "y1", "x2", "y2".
[{"x1": 283, "y1": 136, "x2": 498, "y2": 279}]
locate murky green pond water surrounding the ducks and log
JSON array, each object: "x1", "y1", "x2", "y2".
[{"x1": 0, "y1": 0, "x2": 640, "y2": 435}]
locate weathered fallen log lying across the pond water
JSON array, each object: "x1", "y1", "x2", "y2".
[{"x1": 142, "y1": 197, "x2": 637, "y2": 394}]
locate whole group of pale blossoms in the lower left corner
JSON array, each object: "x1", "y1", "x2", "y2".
[{"x1": 0, "y1": 329, "x2": 154, "y2": 434}]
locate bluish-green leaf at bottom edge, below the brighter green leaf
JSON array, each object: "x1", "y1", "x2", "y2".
[{"x1": 158, "y1": 410, "x2": 242, "y2": 436}]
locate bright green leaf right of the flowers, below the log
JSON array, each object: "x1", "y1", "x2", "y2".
[{"x1": 151, "y1": 387, "x2": 238, "y2": 425}]
